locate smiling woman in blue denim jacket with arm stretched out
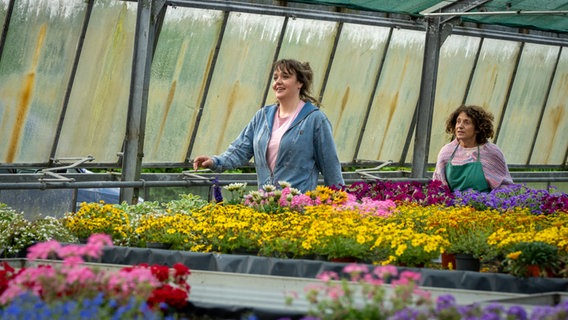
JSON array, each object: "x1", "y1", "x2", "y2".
[{"x1": 193, "y1": 59, "x2": 344, "y2": 192}]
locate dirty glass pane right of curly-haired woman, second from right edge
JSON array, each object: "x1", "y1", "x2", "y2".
[{"x1": 497, "y1": 43, "x2": 566, "y2": 165}]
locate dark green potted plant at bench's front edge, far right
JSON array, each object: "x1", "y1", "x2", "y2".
[{"x1": 503, "y1": 241, "x2": 560, "y2": 277}]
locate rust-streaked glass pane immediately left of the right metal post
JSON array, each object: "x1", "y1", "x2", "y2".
[{"x1": 358, "y1": 29, "x2": 424, "y2": 161}]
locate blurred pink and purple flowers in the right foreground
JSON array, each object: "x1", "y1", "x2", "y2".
[{"x1": 288, "y1": 264, "x2": 568, "y2": 320}]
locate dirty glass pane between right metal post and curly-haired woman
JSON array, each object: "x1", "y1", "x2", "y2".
[{"x1": 428, "y1": 35, "x2": 481, "y2": 163}]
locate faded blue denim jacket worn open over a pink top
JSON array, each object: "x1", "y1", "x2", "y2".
[{"x1": 211, "y1": 102, "x2": 345, "y2": 192}]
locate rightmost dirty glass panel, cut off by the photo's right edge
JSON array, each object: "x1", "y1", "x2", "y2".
[{"x1": 530, "y1": 48, "x2": 568, "y2": 165}]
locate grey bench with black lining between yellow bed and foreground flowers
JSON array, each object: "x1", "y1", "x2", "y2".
[{"x1": 2, "y1": 251, "x2": 568, "y2": 319}]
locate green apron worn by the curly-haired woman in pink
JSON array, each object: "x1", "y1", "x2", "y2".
[{"x1": 446, "y1": 144, "x2": 491, "y2": 192}]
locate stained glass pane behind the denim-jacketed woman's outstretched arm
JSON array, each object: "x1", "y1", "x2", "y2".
[{"x1": 192, "y1": 12, "x2": 284, "y2": 157}]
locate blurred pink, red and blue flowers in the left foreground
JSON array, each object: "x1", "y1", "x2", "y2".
[{"x1": 0, "y1": 234, "x2": 190, "y2": 319}]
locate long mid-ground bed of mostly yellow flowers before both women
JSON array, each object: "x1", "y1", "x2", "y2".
[{"x1": 3, "y1": 181, "x2": 568, "y2": 277}]
